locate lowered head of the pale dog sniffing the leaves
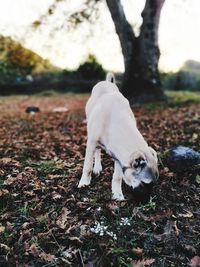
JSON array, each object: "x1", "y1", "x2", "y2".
[{"x1": 124, "y1": 147, "x2": 158, "y2": 189}]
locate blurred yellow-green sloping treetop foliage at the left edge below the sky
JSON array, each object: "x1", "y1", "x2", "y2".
[{"x1": 0, "y1": 35, "x2": 56, "y2": 83}]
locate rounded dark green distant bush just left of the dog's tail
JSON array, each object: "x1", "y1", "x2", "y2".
[{"x1": 77, "y1": 55, "x2": 106, "y2": 80}]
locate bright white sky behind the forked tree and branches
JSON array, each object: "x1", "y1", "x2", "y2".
[{"x1": 0, "y1": 0, "x2": 200, "y2": 71}]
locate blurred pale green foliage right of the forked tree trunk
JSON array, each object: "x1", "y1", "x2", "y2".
[{"x1": 161, "y1": 60, "x2": 200, "y2": 91}]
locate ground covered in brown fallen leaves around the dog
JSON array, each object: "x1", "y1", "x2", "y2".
[{"x1": 0, "y1": 95, "x2": 200, "y2": 267}]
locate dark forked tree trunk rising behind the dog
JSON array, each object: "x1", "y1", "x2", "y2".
[{"x1": 106, "y1": 0, "x2": 165, "y2": 103}]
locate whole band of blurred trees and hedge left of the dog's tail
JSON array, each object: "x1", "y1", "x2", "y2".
[{"x1": 0, "y1": 44, "x2": 106, "y2": 95}]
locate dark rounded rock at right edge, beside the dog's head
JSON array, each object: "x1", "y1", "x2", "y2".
[{"x1": 166, "y1": 146, "x2": 200, "y2": 172}]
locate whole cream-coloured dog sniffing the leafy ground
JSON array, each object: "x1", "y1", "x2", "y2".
[{"x1": 78, "y1": 73, "x2": 158, "y2": 201}]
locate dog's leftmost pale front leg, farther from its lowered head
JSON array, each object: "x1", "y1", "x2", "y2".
[{"x1": 78, "y1": 139, "x2": 96, "y2": 188}]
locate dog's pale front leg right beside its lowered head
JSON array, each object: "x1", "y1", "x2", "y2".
[{"x1": 112, "y1": 161, "x2": 124, "y2": 200}]
